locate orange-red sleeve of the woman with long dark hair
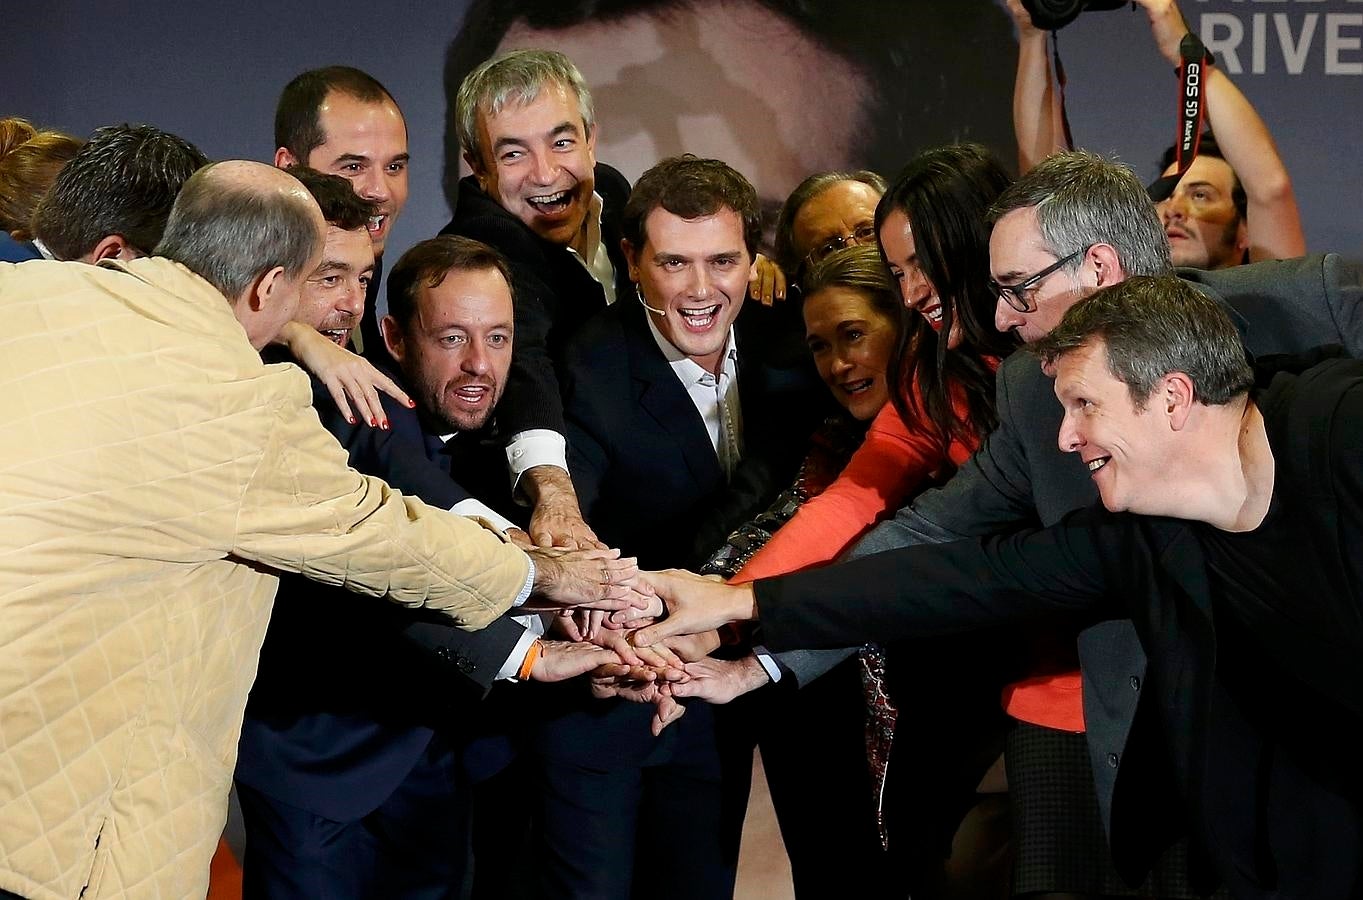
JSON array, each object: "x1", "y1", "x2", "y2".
[{"x1": 732, "y1": 404, "x2": 946, "y2": 584}]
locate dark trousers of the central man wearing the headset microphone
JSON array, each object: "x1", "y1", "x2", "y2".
[{"x1": 536, "y1": 701, "x2": 752, "y2": 900}]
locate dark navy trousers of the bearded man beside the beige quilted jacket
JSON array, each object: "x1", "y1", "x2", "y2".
[{"x1": 237, "y1": 738, "x2": 472, "y2": 900}]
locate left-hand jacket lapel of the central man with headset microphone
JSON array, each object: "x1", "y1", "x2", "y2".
[{"x1": 624, "y1": 304, "x2": 724, "y2": 484}]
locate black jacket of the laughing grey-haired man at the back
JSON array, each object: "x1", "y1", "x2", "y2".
[{"x1": 440, "y1": 165, "x2": 634, "y2": 436}]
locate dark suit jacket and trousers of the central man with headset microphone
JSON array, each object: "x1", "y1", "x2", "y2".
[{"x1": 533, "y1": 290, "x2": 827, "y2": 897}]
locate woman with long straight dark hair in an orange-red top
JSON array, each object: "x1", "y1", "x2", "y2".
[{"x1": 736, "y1": 145, "x2": 1015, "y2": 581}]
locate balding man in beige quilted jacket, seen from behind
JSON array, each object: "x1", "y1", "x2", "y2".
[{"x1": 0, "y1": 162, "x2": 639, "y2": 900}]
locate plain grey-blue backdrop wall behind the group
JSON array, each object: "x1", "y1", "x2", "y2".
[{"x1": 10, "y1": 0, "x2": 1363, "y2": 263}]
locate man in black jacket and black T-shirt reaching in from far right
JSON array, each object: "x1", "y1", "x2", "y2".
[{"x1": 639, "y1": 275, "x2": 1363, "y2": 897}]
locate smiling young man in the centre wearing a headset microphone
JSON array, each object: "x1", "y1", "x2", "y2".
[{"x1": 523, "y1": 157, "x2": 819, "y2": 899}]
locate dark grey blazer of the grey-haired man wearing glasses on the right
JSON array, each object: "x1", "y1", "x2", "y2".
[{"x1": 839, "y1": 254, "x2": 1363, "y2": 884}]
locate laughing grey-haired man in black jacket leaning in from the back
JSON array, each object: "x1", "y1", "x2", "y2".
[{"x1": 442, "y1": 50, "x2": 631, "y2": 556}]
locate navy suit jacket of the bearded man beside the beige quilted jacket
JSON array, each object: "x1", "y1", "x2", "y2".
[{"x1": 236, "y1": 380, "x2": 525, "y2": 821}]
